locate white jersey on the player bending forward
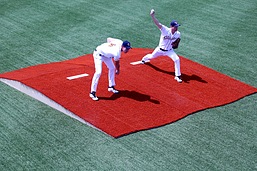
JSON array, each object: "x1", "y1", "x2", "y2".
[{"x1": 96, "y1": 39, "x2": 123, "y2": 61}]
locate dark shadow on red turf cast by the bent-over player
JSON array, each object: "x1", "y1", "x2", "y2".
[{"x1": 98, "y1": 90, "x2": 160, "y2": 104}]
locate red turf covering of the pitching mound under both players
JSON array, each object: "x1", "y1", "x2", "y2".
[{"x1": 0, "y1": 48, "x2": 257, "y2": 137}]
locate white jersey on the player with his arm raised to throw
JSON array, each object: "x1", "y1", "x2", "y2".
[{"x1": 159, "y1": 25, "x2": 180, "y2": 50}]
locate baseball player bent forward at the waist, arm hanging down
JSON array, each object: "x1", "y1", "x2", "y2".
[{"x1": 89, "y1": 37, "x2": 131, "y2": 100}]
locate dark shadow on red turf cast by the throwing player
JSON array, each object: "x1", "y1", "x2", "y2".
[{"x1": 145, "y1": 63, "x2": 208, "y2": 83}]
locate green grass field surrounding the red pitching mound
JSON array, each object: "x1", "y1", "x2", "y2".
[{"x1": 0, "y1": 0, "x2": 257, "y2": 171}]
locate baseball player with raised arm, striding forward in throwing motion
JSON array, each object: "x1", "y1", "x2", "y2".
[{"x1": 142, "y1": 9, "x2": 182, "y2": 83}]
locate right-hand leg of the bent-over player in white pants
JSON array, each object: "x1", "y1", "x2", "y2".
[{"x1": 103, "y1": 58, "x2": 119, "y2": 93}]
